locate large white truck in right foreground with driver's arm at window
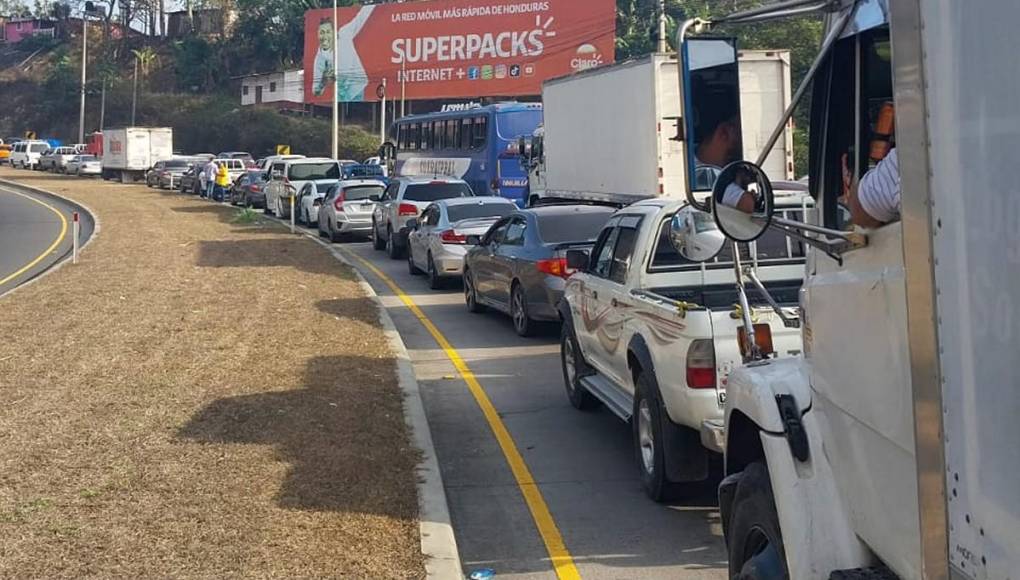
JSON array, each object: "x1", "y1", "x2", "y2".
[{"x1": 678, "y1": 0, "x2": 1020, "y2": 579}]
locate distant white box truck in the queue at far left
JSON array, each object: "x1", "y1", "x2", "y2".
[{"x1": 103, "y1": 126, "x2": 173, "y2": 183}]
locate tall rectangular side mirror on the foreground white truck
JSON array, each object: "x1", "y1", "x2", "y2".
[{"x1": 677, "y1": 38, "x2": 744, "y2": 211}]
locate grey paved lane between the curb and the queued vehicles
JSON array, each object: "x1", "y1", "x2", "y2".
[{"x1": 344, "y1": 237, "x2": 726, "y2": 579}]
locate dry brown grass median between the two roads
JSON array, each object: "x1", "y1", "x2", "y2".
[{"x1": 0, "y1": 165, "x2": 423, "y2": 578}]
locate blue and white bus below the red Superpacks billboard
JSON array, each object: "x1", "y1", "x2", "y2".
[{"x1": 390, "y1": 102, "x2": 542, "y2": 207}]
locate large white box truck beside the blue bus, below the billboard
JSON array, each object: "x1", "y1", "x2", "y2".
[{"x1": 524, "y1": 50, "x2": 794, "y2": 204}]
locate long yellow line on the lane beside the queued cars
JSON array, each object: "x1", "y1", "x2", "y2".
[{"x1": 343, "y1": 250, "x2": 580, "y2": 580}]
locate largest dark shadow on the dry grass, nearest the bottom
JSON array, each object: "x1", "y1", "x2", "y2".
[{"x1": 177, "y1": 357, "x2": 419, "y2": 520}]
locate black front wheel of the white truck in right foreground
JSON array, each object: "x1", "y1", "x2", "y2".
[{"x1": 726, "y1": 463, "x2": 789, "y2": 580}]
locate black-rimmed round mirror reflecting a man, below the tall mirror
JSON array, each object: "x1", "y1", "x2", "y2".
[{"x1": 712, "y1": 161, "x2": 775, "y2": 242}]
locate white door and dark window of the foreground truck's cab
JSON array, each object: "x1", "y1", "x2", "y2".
[{"x1": 803, "y1": 28, "x2": 920, "y2": 577}]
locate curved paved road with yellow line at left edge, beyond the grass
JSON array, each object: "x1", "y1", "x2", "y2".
[{"x1": 0, "y1": 184, "x2": 91, "y2": 295}]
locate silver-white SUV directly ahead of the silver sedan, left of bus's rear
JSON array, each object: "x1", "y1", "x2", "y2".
[{"x1": 371, "y1": 177, "x2": 474, "y2": 260}]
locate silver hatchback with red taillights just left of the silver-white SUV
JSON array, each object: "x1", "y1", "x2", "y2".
[{"x1": 317, "y1": 179, "x2": 386, "y2": 242}]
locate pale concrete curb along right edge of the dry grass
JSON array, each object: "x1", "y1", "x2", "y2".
[{"x1": 262, "y1": 213, "x2": 464, "y2": 580}]
